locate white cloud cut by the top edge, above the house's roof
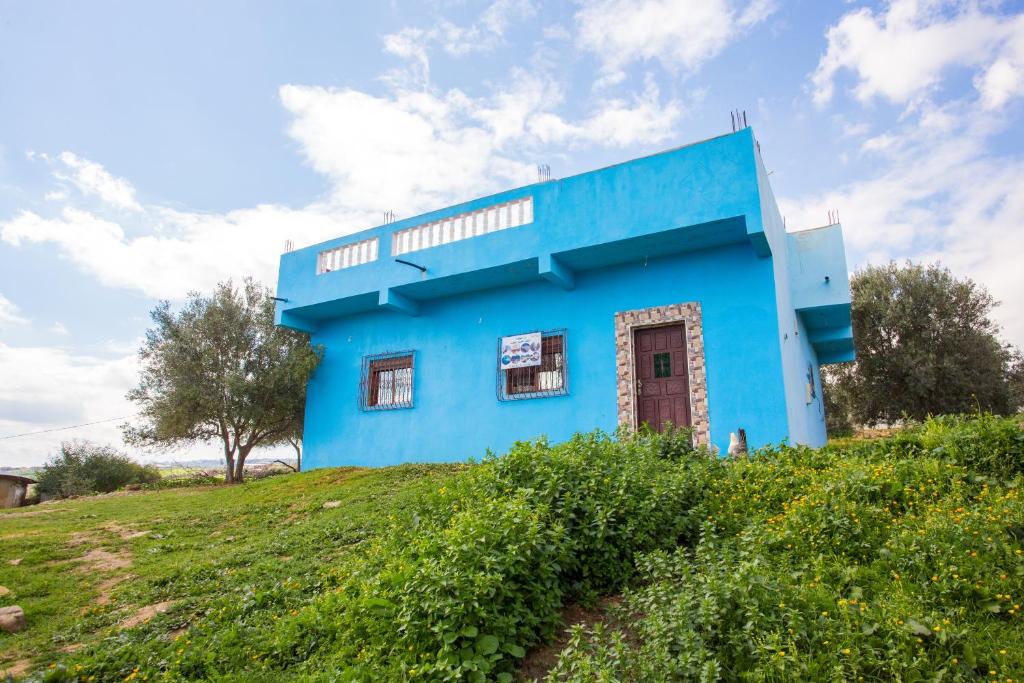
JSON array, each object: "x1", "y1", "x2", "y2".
[{"x1": 575, "y1": 0, "x2": 775, "y2": 84}]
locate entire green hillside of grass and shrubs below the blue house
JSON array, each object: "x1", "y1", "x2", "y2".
[{"x1": 0, "y1": 416, "x2": 1024, "y2": 681}]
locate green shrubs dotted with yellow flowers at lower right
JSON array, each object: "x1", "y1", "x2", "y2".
[{"x1": 549, "y1": 418, "x2": 1024, "y2": 681}]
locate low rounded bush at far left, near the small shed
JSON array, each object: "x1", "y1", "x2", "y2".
[{"x1": 37, "y1": 441, "x2": 160, "y2": 498}]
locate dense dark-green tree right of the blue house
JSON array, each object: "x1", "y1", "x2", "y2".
[{"x1": 825, "y1": 262, "x2": 1013, "y2": 424}]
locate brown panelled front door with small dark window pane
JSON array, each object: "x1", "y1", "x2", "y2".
[{"x1": 633, "y1": 325, "x2": 690, "y2": 431}]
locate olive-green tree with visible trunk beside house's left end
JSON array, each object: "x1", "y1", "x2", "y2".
[{"x1": 125, "y1": 278, "x2": 323, "y2": 483}]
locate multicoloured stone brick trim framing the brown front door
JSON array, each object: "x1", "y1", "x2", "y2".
[{"x1": 615, "y1": 301, "x2": 711, "y2": 446}]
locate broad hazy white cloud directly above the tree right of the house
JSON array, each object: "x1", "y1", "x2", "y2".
[{"x1": 780, "y1": 102, "x2": 1024, "y2": 346}]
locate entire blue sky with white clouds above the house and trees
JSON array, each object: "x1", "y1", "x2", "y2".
[{"x1": 0, "y1": 0, "x2": 1024, "y2": 466}]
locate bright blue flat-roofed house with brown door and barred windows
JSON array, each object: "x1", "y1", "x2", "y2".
[{"x1": 276, "y1": 128, "x2": 854, "y2": 467}]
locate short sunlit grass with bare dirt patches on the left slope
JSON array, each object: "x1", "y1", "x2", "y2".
[{"x1": 0, "y1": 466, "x2": 458, "y2": 671}]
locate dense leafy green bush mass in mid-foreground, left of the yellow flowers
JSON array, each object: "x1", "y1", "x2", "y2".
[{"x1": 260, "y1": 433, "x2": 715, "y2": 681}]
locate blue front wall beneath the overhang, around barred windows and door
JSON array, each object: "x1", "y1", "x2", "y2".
[{"x1": 305, "y1": 245, "x2": 787, "y2": 467}]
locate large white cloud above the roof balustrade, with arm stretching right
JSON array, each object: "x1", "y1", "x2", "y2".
[{"x1": 281, "y1": 71, "x2": 682, "y2": 215}]
